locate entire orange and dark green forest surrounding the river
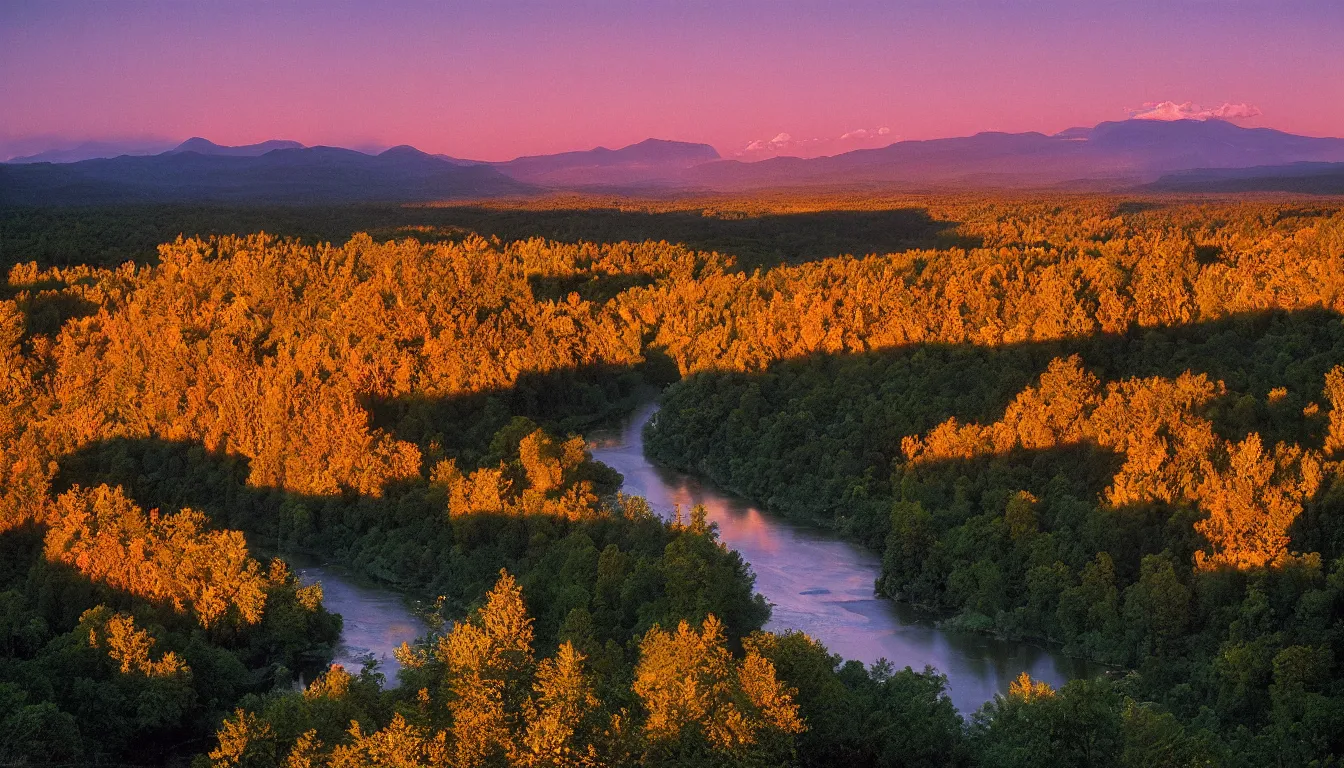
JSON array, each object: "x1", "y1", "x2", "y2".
[{"x1": 0, "y1": 191, "x2": 1344, "y2": 768}]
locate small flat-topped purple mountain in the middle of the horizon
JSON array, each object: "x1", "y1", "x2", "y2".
[{"x1": 493, "y1": 139, "x2": 719, "y2": 186}]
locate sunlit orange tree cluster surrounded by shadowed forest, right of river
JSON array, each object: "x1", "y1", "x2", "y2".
[{"x1": 902, "y1": 356, "x2": 1321, "y2": 568}]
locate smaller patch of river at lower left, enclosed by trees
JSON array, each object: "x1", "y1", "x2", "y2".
[{"x1": 296, "y1": 566, "x2": 426, "y2": 686}]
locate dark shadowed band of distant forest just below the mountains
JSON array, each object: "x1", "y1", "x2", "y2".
[{"x1": 0, "y1": 196, "x2": 976, "y2": 277}]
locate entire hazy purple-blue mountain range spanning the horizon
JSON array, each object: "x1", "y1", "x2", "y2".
[{"x1": 0, "y1": 120, "x2": 1344, "y2": 204}]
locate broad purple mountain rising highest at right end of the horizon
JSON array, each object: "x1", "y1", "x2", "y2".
[{"x1": 683, "y1": 120, "x2": 1344, "y2": 188}]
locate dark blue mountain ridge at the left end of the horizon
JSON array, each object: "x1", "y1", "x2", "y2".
[{"x1": 0, "y1": 147, "x2": 532, "y2": 204}]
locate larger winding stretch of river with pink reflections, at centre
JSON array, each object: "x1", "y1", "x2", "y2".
[{"x1": 591, "y1": 405, "x2": 1098, "y2": 713}]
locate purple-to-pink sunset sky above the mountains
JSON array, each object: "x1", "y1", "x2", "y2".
[{"x1": 0, "y1": 0, "x2": 1344, "y2": 160}]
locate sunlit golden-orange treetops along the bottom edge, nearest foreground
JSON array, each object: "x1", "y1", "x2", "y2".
[{"x1": 210, "y1": 572, "x2": 805, "y2": 768}]
